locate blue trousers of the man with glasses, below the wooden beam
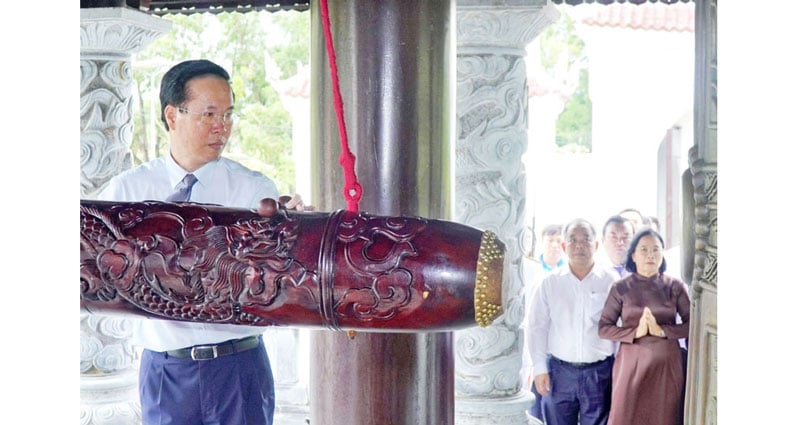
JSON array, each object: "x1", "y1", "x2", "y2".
[{"x1": 139, "y1": 340, "x2": 275, "y2": 425}]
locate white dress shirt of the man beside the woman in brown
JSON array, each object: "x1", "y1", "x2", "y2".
[{"x1": 528, "y1": 264, "x2": 617, "y2": 376}]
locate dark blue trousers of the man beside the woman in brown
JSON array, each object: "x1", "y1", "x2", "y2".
[{"x1": 542, "y1": 356, "x2": 616, "y2": 425}]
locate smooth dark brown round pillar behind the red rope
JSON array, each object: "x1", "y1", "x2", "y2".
[{"x1": 310, "y1": 0, "x2": 454, "y2": 425}]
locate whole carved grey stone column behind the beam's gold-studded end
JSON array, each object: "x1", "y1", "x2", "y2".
[{"x1": 455, "y1": 0, "x2": 558, "y2": 425}]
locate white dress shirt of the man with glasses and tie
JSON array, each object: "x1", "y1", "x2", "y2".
[{"x1": 98, "y1": 155, "x2": 279, "y2": 351}]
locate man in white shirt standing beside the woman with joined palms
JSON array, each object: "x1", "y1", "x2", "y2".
[{"x1": 527, "y1": 219, "x2": 616, "y2": 425}]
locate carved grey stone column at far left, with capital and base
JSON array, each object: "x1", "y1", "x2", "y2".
[{"x1": 80, "y1": 7, "x2": 171, "y2": 425}]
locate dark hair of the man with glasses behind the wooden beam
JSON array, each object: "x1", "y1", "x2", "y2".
[{"x1": 159, "y1": 59, "x2": 230, "y2": 131}]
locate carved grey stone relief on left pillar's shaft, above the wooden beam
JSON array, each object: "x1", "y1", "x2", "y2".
[{"x1": 80, "y1": 60, "x2": 133, "y2": 196}]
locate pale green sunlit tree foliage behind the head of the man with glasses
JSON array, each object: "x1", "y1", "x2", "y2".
[{"x1": 131, "y1": 12, "x2": 309, "y2": 193}]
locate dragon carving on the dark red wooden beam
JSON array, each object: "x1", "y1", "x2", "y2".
[{"x1": 81, "y1": 202, "x2": 319, "y2": 325}]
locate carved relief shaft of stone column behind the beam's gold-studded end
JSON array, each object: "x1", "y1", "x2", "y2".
[{"x1": 456, "y1": 54, "x2": 527, "y2": 394}]
